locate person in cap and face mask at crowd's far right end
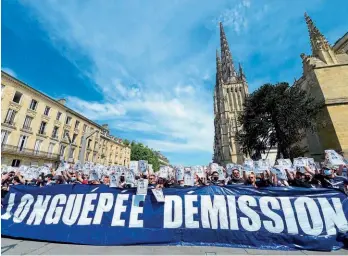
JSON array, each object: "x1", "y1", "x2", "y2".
[{"x1": 315, "y1": 166, "x2": 348, "y2": 195}]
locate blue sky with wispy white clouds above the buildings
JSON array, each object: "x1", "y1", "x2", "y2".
[{"x1": 1, "y1": 0, "x2": 348, "y2": 165}]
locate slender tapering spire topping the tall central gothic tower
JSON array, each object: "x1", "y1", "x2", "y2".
[{"x1": 220, "y1": 22, "x2": 237, "y2": 83}]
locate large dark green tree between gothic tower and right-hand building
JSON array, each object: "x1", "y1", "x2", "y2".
[{"x1": 237, "y1": 83, "x2": 322, "y2": 158}]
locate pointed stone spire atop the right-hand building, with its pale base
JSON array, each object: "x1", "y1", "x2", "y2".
[{"x1": 304, "y1": 13, "x2": 337, "y2": 64}]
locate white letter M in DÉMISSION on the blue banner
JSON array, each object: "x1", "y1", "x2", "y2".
[{"x1": 201, "y1": 195, "x2": 228, "y2": 229}]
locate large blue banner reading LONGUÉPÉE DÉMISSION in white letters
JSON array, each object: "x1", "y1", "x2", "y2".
[{"x1": 1, "y1": 185, "x2": 348, "y2": 251}]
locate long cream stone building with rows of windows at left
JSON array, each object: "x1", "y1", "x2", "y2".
[{"x1": 1, "y1": 71, "x2": 130, "y2": 166}]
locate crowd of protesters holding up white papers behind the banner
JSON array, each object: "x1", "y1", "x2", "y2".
[{"x1": 1, "y1": 158, "x2": 348, "y2": 198}]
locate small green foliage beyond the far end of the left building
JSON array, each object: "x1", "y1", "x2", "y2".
[{"x1": 130, "y1": 141, "x2": 160, "y2": 172}]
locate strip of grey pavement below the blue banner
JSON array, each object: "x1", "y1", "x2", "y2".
[{"x1": 1, "y1": 238, "x2": 348, "y2": 255}]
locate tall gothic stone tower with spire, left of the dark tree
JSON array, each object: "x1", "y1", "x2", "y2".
[{"x1": 213, "y1": 22, "x2": 248, "y2": 165}]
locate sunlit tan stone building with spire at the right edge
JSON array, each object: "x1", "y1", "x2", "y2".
[{"x1": 294, "y1": 14, "x2": 348, "y2": 160}]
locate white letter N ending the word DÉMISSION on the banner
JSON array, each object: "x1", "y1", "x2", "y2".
[{"x1": 318, "y1": 198, "x2": 348, "y2": 235}]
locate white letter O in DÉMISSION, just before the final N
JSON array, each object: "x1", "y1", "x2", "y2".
[{"x1": 294, "y1": 197, "x2": 323, "y2": 236}]
